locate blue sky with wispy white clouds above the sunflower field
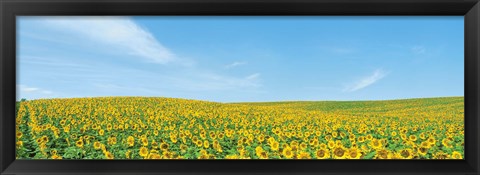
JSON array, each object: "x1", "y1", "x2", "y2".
[{"x1": 17, "y1": 16, "x2": 464, "y2": 102}]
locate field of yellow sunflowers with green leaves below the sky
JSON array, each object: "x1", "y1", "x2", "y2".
[{"x1": 16, "y1": 97, "x2": 464, "y2": 159}]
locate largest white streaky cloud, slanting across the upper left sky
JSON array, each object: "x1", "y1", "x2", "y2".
[{"x1": 38, "y1": 17, "x2": 175, "y2": 64}]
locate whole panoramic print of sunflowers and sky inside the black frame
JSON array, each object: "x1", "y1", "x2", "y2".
[{"x1": 16, "y1": 16, "x2": 465, "y2": 160}]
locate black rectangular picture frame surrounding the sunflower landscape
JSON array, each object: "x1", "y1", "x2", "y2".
[{"x1": 0, "y1": 0, "x2": 480, "y2": 175}]
